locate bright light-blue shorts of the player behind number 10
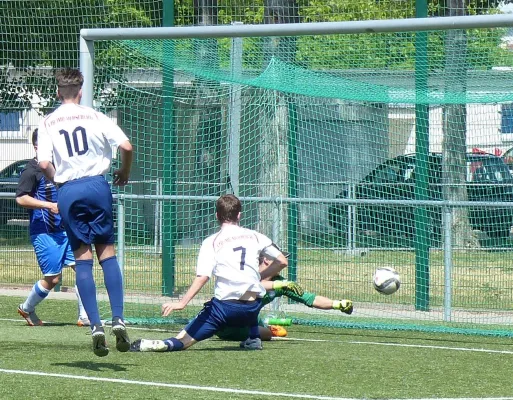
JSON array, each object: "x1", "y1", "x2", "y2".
[{"x1": 30, "y1": 232, "x2": 75, "y2": 276}]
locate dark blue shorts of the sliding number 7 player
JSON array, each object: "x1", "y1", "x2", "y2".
[{"x1": 184, "y1": 298, "x2": 262, "y2": 342}]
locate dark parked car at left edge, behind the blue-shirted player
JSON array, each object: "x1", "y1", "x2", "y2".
[{"x1": 0, "y1": 159, "x2": 31, "y2": 225}]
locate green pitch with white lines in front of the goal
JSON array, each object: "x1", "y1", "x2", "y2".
[{"x1": 0, "y1": 296, "x2": 513, "y2": 400}]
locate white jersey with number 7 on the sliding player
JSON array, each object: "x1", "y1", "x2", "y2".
[{"x1": 196, "y1": 224, "x2": 272, "y2": 300}]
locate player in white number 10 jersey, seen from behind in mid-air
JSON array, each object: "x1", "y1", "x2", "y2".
[{"x1": 37, "y1": 68, "x2": 133, "y2": 357}]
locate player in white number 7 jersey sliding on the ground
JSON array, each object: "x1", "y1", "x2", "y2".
[{"x1": 131, "y1": 194, "x2": 287, "y2": 352}]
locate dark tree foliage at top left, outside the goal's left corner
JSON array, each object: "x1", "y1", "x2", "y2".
[{"x1": 0, "y1": 0, "x2": 160, "y2": 113}]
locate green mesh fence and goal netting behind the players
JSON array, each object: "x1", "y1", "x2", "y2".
[{"x1": 0, "y1": 0, "x2": 513, "y2": 335}]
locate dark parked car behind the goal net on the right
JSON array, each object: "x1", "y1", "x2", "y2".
[{"x1": 328, "y1": 153, "x2": 513, "y2": 241}]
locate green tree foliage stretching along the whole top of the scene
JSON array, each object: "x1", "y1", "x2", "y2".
[{"x1": 0, "y1": 0, "x2": 513, "y2": 113}]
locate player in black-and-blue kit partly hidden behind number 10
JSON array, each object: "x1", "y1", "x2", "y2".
[{"x1": 16, "y1": 129, "x2": 89, "y2": 326}]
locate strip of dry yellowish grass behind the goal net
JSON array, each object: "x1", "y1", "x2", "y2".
[{"x1": 5, "y1": 245, "x2": 513, "y2": 310}]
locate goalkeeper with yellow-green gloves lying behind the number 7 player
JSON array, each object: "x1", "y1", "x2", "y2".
[{"x1": 216, "y1": 256, "x2": 353, "y2": 346}]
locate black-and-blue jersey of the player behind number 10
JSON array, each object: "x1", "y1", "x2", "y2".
[{"x1": 16, "y1": 159, "x2": 64, "y2": 236}]
